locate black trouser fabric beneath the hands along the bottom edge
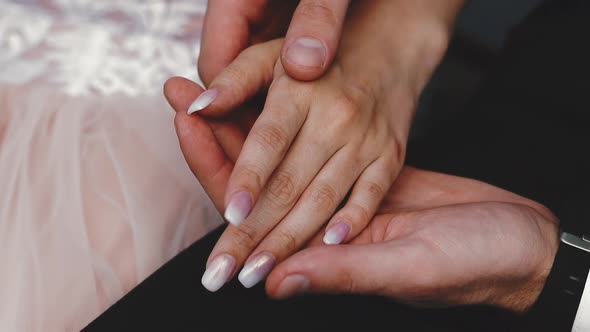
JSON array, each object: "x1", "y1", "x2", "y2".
[{"x1": 86, "y1": 229, "x2": 524, "y2": 332}]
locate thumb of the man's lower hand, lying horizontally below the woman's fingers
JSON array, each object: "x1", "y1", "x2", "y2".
[{"x1": 266, "y1": 243, "x2": 408, "y2": 298}]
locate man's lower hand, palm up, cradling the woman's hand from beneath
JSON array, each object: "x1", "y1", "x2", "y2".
[{"x1": 165, "y1": 79, "x2": 558, "y2": 311}]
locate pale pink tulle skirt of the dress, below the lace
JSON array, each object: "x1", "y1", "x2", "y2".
[{"x1": 0, "y1": 84, "x2": 221, "y2": 331}]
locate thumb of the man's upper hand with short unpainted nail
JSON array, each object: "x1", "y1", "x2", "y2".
[{"x1": 281, "y1": 0, "x2": 350, "y2": 81}]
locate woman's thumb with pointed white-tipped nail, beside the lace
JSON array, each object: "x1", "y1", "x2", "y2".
[{"x1": 188, "y1": 39, "x2": 283, "y2": 116}]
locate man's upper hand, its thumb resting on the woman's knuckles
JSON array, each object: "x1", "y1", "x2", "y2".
[{"x1": 199, "y1": 0, "x2": 350, "y2": 85}]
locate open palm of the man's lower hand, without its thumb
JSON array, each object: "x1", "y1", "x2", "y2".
[{"x1": 338, "y1": 168, "x2": 556, "y2": 304}]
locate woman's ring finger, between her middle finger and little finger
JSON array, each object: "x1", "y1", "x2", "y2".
[{"x1": 239, "y1": 149, "x2": 364, "y2": 288}]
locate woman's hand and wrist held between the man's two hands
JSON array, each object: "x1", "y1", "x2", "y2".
[{"x1": 190, "y1": 0, "x2": 468, "y2": 290}]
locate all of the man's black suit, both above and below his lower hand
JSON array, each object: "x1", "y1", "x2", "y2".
[{"x1": 87, "y1": 0, "x2": 590, "y2": 331}]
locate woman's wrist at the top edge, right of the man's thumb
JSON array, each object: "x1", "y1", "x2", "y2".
[{"x1": 338, "y1": 0, "x2": 464, "y2": 99}]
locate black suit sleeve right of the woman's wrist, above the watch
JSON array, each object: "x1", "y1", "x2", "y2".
[{"x1": 408, "y1": 0, "x2": 590, "y2": 234}]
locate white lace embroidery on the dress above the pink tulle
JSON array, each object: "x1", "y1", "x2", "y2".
[{"x1": 0, "y1": 0, "x2": 205, "y2": 96}]
